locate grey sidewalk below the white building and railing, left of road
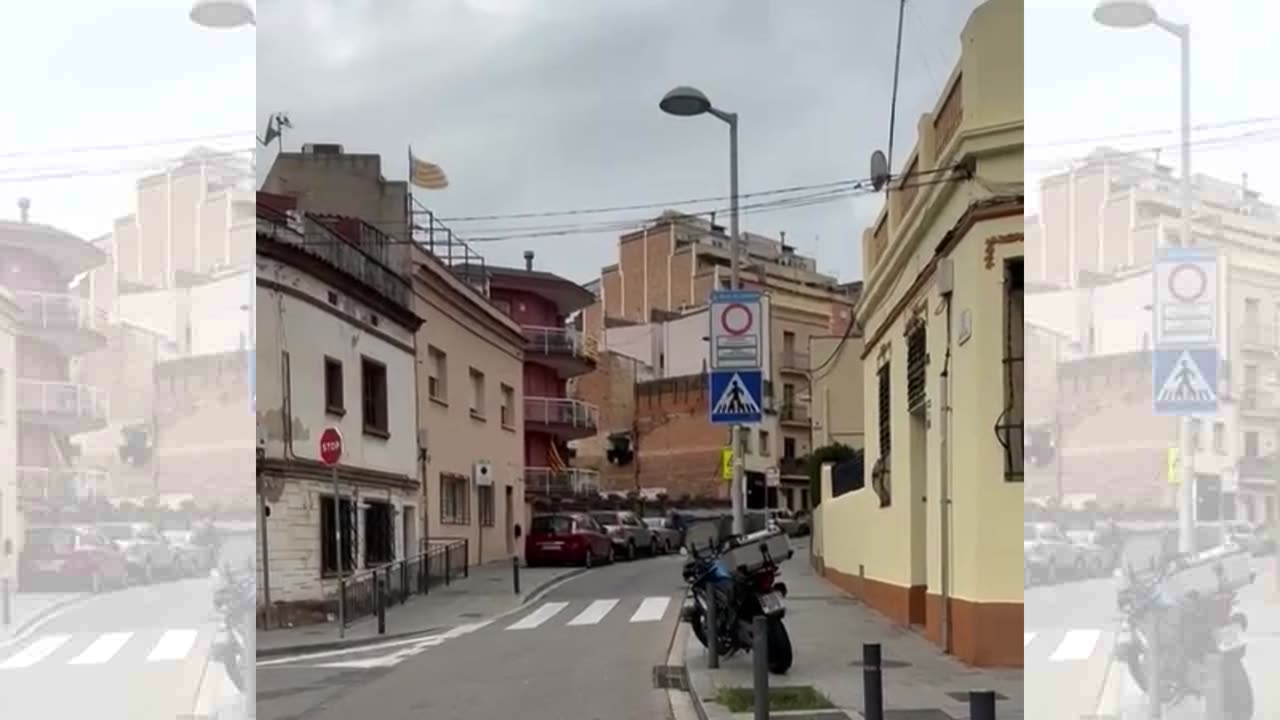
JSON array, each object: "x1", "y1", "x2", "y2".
[{"x1": 257, "y1": 560, "x2": 584, "y2": 657}]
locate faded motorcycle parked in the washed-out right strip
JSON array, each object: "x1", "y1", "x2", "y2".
[{"x1": 1116, "y1": 562, "x2": 1253, "y2": 720}]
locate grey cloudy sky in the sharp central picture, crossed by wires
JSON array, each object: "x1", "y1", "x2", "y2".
[{"x1": 257, "y1": 0, "x2": 977, "y2": 282}]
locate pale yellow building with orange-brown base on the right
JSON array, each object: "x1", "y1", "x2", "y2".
[{"x1": 819, "y1": 0, "x2": 1023, "y2": 666}]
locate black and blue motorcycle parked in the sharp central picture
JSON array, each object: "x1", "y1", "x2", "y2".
[{"x1": 681, "y1": 527, "x2": 792, "y2": 675}]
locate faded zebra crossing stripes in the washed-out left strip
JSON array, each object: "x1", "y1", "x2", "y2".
[{"x1": 0, "y1": 629, "x2": 212, "y2": 674}]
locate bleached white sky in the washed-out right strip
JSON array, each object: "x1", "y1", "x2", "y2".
[{"x1": 1024, "y1": 0, "x2": 1280, "y2": 212}]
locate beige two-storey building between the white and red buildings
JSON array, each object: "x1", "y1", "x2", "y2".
[{"x1": 413, "y1": 249, "x2": 527, "y2": 564}]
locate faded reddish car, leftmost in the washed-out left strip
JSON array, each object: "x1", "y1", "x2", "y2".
[{"x1": 19, "y1": 527, "x2": 129, "y2": 592}]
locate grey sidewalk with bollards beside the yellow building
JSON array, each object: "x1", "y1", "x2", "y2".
[{"x1": 685, "y1": 543, "x2": 1023, "y2": 720}]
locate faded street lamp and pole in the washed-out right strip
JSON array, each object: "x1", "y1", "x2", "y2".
[{"x1": 1093, "y1": 0, "x2": 1196, "y2": 553}]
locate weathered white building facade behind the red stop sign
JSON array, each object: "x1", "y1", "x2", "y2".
[{"x1": 255, "y1": 193, "x2": 424, "y2": 605}]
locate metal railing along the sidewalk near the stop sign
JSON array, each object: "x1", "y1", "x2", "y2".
[{"x1": 338, "y1": 538, "x2": 470, "y2": 626}]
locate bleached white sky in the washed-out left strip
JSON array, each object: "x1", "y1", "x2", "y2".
[{"x1": 0, "y1": 0, "x2": 255, "y2": 238}]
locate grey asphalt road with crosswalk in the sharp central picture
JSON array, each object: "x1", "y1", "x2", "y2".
[{"x1": 257, "y1": 548, "x2": 684, "y2": 720}]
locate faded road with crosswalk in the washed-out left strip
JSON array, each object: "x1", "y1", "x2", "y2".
[{"x1": 0, "y1": 537, "x2": 252, "y2": 720}]
